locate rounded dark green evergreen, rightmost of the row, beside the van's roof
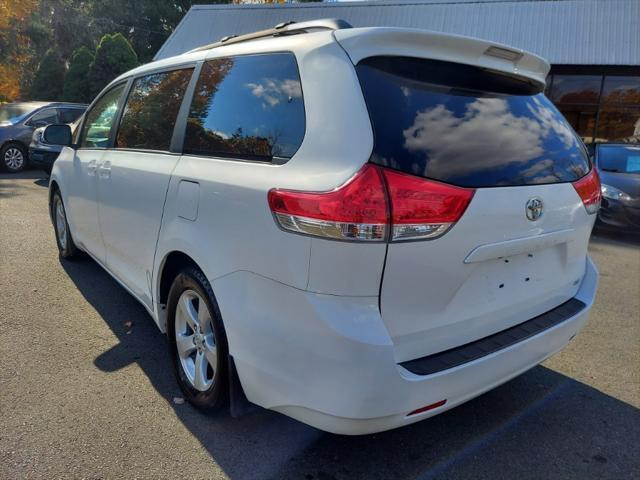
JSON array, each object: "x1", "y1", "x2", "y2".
[{"x1": 89, "y1": 33, "x2": 138, "y2": 97}]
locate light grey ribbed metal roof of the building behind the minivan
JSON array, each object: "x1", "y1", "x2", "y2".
[{"x1": 155, "y1": 0, "x2": 640, "y2": 65}]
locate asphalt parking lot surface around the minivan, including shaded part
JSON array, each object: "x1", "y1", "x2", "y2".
[{"x1": 0, "y1": 172, "x2": 640, "y2": 480}]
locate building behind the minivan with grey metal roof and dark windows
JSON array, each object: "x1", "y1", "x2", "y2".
[{"x1": 155, "y1": 0, "x2": 640, "y2": 143}]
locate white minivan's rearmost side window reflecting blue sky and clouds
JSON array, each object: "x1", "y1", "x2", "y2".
[{"x1": 184, "y1": 53, "x2": 305, "y2": 161}]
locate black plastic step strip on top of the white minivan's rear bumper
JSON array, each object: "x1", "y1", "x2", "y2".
[{"x1": 400, "y1": 298, "x2": 586, "y2": 375}]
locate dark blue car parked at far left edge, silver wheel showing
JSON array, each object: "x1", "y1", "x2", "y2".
[{"x1": 0, "y1": 102, "x2": 87, "y2": 172}]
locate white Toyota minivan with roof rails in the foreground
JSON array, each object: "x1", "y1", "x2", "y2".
[{"x1": 44, "y1": 20, "x2": 600, "y2": 434}]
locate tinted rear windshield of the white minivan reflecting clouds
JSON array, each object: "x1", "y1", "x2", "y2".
[{"x1": 356, "y1": 57, "x2": 589, "y2": 187}]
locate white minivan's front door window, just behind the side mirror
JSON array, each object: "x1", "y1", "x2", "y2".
[{"x1": 80, "y1": 83, "x2": 125, "y2": 148}]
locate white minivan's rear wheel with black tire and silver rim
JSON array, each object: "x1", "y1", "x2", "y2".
[{"x1": 167, "y1": 267, "x2": 229, "y2": 411}]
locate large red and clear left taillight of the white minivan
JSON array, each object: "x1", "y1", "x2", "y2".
[{"x1": 269, "y1": 164, "x2": 474, "y2": 241}]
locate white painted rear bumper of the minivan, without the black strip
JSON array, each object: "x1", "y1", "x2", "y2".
[{"x1": 214, "y1": 259, "x2": 598, "y2": 435}]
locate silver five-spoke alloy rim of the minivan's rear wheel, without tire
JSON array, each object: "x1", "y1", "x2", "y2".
[{"x1": 175, "y1": 290, "x2": 218, "y2": 392}]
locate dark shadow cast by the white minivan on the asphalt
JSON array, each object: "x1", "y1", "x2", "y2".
[{"x1": 62, "y1": 258, "x2": 640, "y2": 480}]
